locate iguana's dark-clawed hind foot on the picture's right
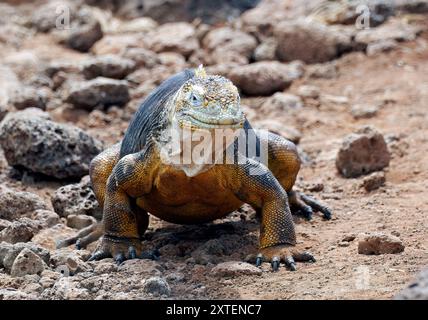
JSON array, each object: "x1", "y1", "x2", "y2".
[{"x1": 288, "y1": 191, "x2": 331, "y2": 220}]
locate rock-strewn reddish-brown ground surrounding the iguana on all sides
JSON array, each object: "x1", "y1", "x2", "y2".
[{"x1": 0, "y1": 0, "x2": 428, "y2": 300}]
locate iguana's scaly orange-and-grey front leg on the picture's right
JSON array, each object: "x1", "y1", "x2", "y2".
[{"x1": 226, "y1": 159, "x2": 315, "y2": 271}]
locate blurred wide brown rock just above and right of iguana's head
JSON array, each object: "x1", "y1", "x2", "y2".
[{"x1": 228, "y1": 61, "x2": 303, "y2": 95}]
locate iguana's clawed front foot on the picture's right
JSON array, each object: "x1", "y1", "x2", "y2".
[{"x1": 251, "y1": 244, "x2": 315, "y2": 271}]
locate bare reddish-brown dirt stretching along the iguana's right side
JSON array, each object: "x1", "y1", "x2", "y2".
[{"x1": 206, "y1": 31, "x2": 428, "y2": 299}]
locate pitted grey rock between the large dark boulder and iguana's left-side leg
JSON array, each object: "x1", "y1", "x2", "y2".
[{"x1": 51, "y1": 176, "x2": 102, "y2": 219}]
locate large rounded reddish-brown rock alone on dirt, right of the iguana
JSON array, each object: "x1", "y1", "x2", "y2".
[{"x1": 336, "y1": 126, "x2": 391, "y2": 178}]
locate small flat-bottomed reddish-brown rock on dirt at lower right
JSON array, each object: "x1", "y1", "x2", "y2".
[{"x1": 358, "y1": 232, "x2": 404, "y2": 255}]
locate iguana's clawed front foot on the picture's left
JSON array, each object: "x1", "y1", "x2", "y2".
[{"x1": 89, "y1": 236, "x2": 159, "y2": 264}]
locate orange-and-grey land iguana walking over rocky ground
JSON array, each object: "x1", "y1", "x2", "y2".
[{"x1": 62, "y1": 67, "x2": 331, "y2": 270}]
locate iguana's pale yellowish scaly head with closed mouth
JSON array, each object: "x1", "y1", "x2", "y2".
[{"x1": 173, "y1": 66, "x2": 245, "y2": 130}]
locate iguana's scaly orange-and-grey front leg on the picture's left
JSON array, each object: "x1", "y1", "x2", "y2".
[{"x1": 90, "y1": 149, "x2": 157, "y2": 263}]
